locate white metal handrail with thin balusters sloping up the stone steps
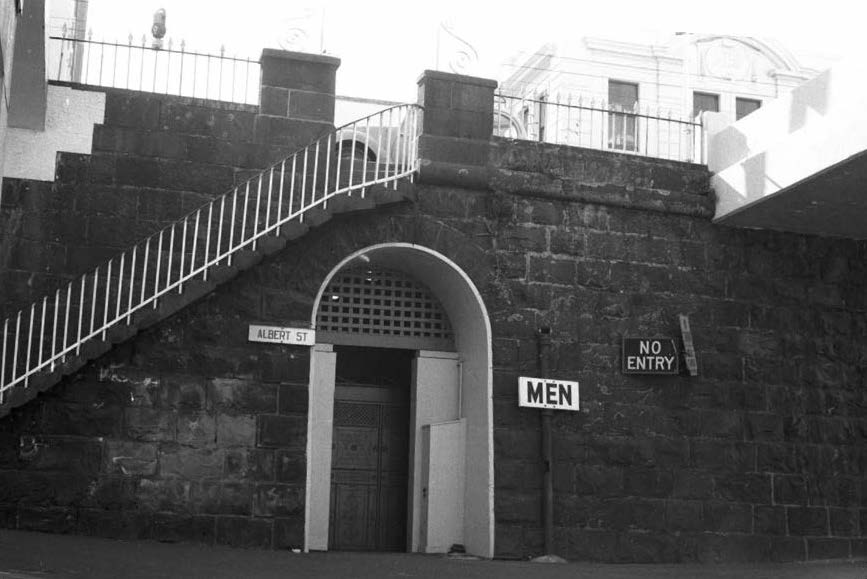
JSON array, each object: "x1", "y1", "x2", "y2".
[{"x1": 0, "y1": 104, "x2": 420, "y2": 404}]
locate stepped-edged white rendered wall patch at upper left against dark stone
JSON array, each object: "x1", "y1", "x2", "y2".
[{"x1": 3, "y1": 85, "x2": 105, "y2": 181}]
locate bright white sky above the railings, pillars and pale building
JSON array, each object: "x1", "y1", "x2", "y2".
[{"x1": 76, "y1": 0, "x2": 864, "y2": 102}]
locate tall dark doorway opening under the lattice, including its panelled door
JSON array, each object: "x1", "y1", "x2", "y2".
[{"x1": 329, "y1": 346, "x2": 415, "y2": 551}]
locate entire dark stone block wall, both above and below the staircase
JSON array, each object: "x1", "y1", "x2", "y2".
[{"x1": 0, "y1": 62, "x2": 867, "y2": 562}]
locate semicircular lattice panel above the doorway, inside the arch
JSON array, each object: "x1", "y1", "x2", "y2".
[{"x1": 316, "y1": 268, "x2": 453, "y2": 340}]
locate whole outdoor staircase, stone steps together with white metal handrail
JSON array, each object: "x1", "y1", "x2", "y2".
[{"x1": 0, "y1": 105, "x2": 420, "y2": 417}]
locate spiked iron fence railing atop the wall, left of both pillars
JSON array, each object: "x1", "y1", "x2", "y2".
[{"x1": 47, "y1": 30, "x2": 261, "y2": 104}]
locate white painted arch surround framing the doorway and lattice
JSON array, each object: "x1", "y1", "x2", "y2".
[{"x1": 304, "y1": 243, "x2": 494, "y2": 558}]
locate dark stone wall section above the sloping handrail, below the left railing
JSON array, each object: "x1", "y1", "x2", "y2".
[{"x1": 0, "y1": 74, "x2": 334, "y2": 318}]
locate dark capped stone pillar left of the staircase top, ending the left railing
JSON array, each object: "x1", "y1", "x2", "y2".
[{"x1": 256, "y1": 48, "x2": 340, "y2": 148}]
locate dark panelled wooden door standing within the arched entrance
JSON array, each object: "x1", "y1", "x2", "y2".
[{"x1": 329, "y1": 386, "x2": 409, "y2": 551}]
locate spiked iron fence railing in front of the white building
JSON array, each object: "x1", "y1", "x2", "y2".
[{"x1": 494, "y1": 94, "x2": 706, "y2": 163}]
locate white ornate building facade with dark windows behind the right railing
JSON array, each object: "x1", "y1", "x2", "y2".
[{"x1": 496, "y1": 34, "x2": 818, "y2": 162}]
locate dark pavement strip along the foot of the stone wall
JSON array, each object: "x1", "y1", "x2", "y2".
[{"x1": 0, "y1": 531, "x2": 867, "y2": 579}]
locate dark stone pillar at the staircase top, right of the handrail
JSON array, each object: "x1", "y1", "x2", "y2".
[{"x1": 418, "y1": 70, "x2": 497, "y2": 187}]
